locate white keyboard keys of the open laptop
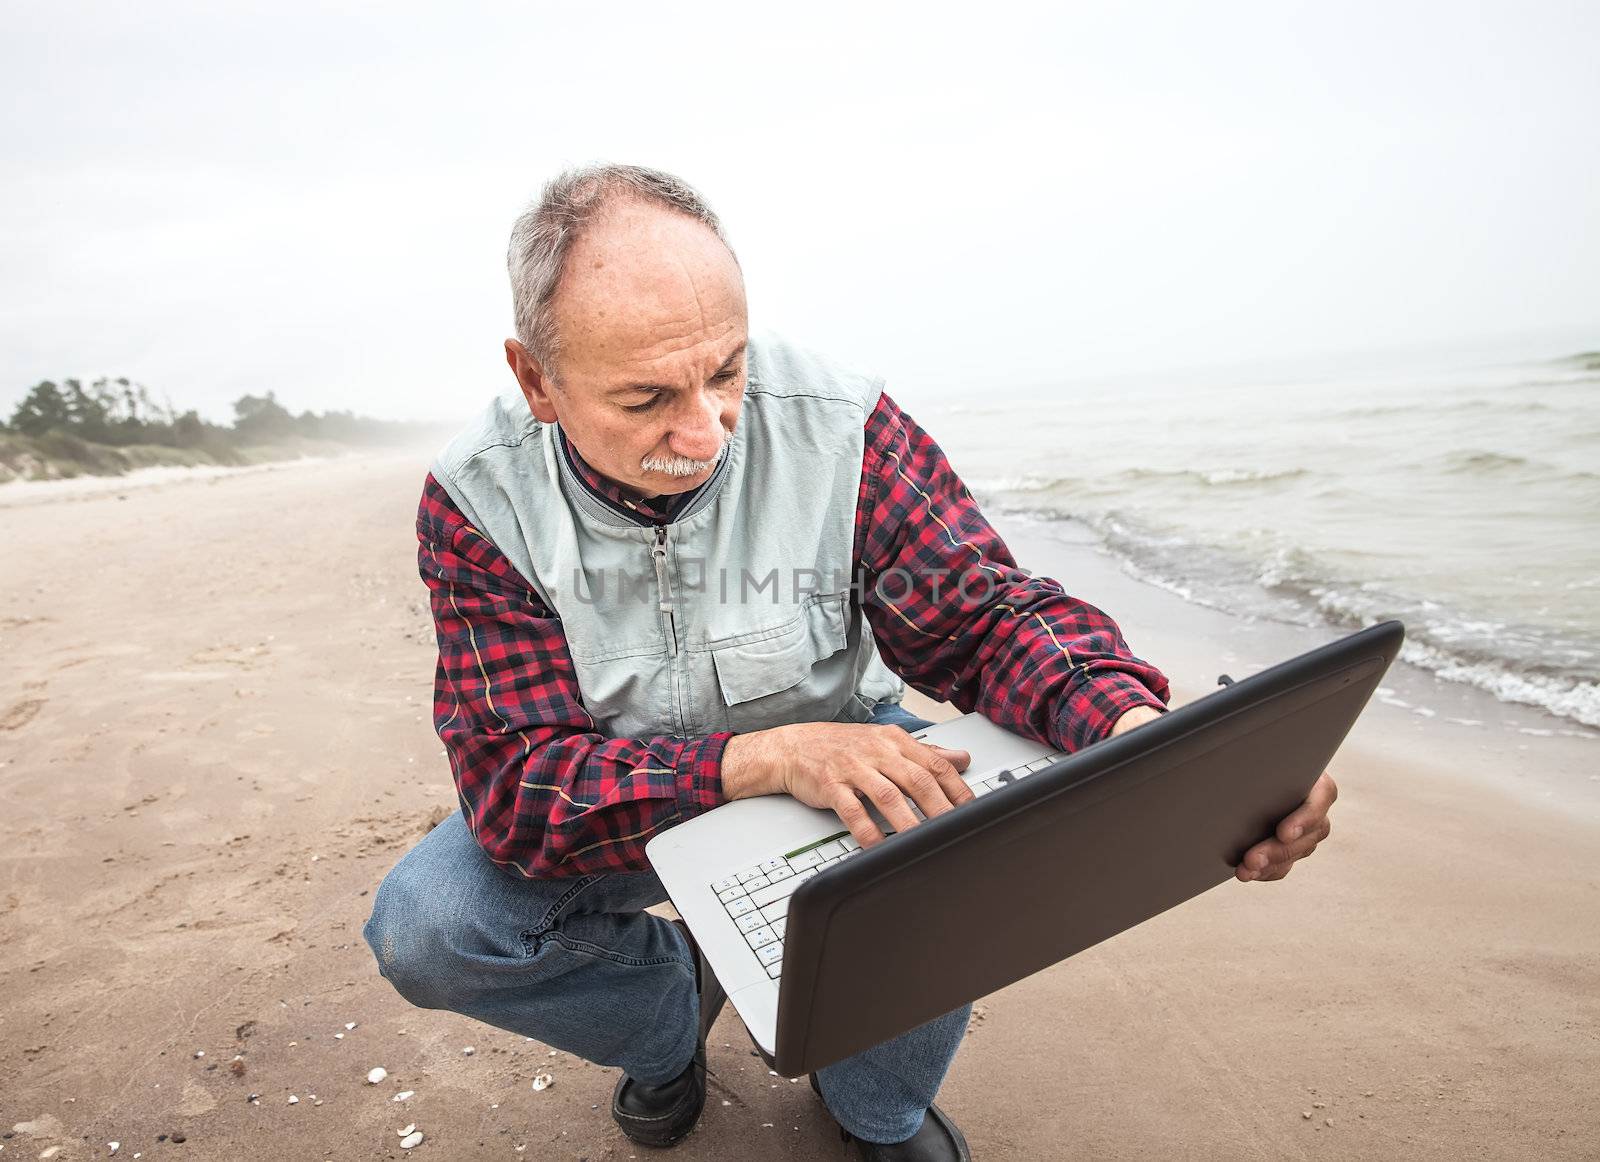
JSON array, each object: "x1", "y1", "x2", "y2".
[{"x1": 710, "y1": 754, "x2": 1062, "y2": 980}]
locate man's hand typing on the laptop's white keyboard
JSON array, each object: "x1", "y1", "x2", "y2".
[{"x1": 722, "y1": 722, "x2": 973, "y2": 847}]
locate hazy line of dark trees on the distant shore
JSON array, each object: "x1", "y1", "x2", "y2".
[{"x1": 0, "y1": 378, "x2": 421, "y2": 456}]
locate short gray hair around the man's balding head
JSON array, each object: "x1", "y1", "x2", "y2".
[{"x1": 506, "y1": 165, "x2": 738, "y2": 373}]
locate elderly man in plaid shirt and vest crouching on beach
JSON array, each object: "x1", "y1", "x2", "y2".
[{"x1": 366, "y1": 166, "x2": 1333, "y2": 1159}]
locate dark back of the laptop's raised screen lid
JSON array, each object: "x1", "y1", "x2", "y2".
[{"x1": 776, "y1": 621, "x2": 1405, "y2": 1077}]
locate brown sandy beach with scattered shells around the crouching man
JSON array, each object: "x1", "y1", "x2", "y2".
[{"x1": 0, "y1": 451, "x2": 1600, "y2": 1162}]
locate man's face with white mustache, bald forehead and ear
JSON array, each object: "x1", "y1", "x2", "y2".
[{"x1": 506, "y1": 202, "x2": 749, "y2": 496}]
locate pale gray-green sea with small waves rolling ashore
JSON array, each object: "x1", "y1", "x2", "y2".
[{"x1": 914, "y1": 344, "x2": 1600, "y2": 727}]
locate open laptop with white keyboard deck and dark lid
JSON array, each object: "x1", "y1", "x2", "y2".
[{"x1": 645, "y1": 621, "x2": 1405, "y2": 1077}]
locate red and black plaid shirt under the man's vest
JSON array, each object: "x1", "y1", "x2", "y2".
[{"x1": 416, "y1": 387, "x2": 1168, "y2": 877}]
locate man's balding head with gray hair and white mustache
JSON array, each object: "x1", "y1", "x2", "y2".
[{"x1": 506, "y1": 168, "x2": 747, "y2": 496}]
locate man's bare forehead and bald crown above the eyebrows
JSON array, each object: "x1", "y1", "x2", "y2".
[{"x1": 554, "y1": 202, "x2": 746, "y2": 378}]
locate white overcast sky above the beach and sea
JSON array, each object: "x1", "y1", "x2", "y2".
[{"x1": 0, "y1": 0, "x2": 1600, "y2": 418}]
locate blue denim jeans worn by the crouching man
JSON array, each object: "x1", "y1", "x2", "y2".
[{"x1": 362, "y1": 703, "x2": 971, "y2": 1141}]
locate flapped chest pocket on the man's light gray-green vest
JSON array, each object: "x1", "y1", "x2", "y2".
[{"x1": 707, "y1": 594, "x2": 851, "y2": 731}]
